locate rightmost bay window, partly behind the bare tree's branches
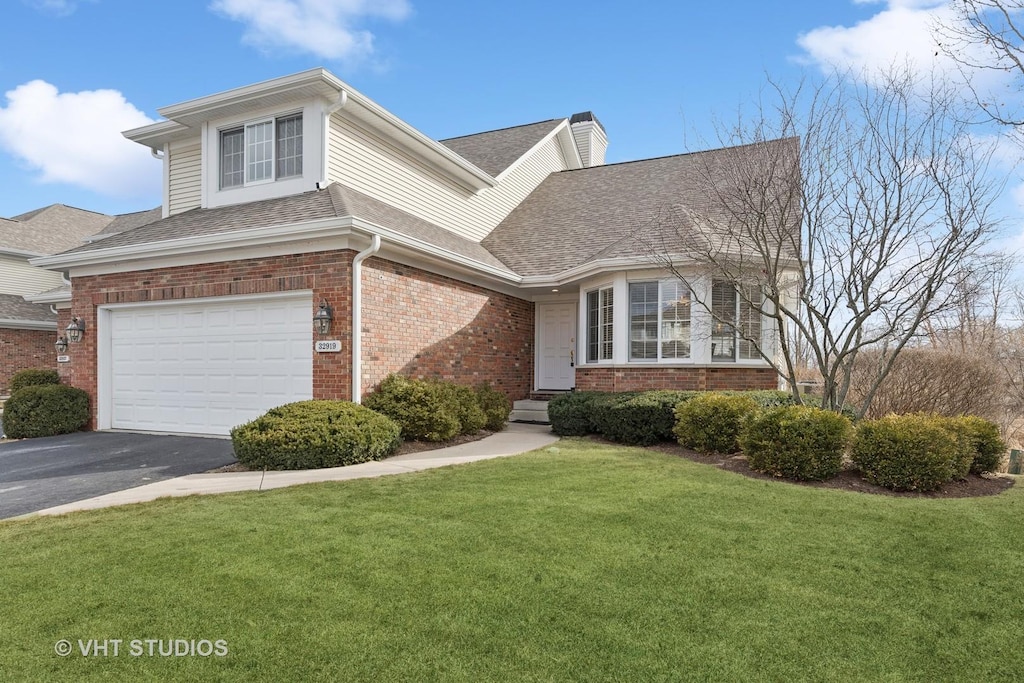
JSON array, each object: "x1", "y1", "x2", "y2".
[{"x1": 711, "y1": 280, "x2": 762, "y2": 362}]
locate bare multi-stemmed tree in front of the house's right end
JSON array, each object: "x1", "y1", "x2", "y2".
[{"x1": 644, "y1": 70, "x2": 1000, "y2": 415}]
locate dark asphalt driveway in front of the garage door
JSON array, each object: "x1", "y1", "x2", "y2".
[{"x1": 0, "y1": 432, "x2": 234, "y2": 519}]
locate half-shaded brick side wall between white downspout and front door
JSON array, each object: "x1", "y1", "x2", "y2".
[{"x1": 362, "y1": 258, "x2": 534, "y2": 400}]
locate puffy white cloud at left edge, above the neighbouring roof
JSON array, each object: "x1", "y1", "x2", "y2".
[{"x1": 0, "y1": 80, "x2": 161, "y2": 197}]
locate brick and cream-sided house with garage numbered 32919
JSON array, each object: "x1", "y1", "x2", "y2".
[{"x1": 32, "y1": 69, "x2": 778, "y2": 434}]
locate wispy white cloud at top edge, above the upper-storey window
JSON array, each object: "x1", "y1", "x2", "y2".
[{"x1": 210, "y1": 0, "x2": 412, "y2": 59}]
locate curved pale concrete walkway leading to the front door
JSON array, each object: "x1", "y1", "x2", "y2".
[{"x1": 25, "y1": 423, "x2": 558, "y2": 517}]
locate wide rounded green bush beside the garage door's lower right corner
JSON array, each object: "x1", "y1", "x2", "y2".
[{"x1": 231, "y1": 400, "x2": 401, "y2": 470}]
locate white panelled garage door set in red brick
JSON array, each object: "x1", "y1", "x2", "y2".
[{"x1": 110, "y1": 295, "x2": 313, "y2": 434}]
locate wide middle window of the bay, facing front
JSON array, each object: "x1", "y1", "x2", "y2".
[{"x1": 630, "y1": 281, "x2": 690, "y2": 360}]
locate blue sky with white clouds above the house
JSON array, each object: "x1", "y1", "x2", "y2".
[{"x1": 0, "y1": 0, "x2": 1024, "y2": 244}]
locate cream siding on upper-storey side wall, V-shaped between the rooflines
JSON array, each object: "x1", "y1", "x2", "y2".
[{"x1": 328, "y1": 114, "x2": 566, "y2": 241}]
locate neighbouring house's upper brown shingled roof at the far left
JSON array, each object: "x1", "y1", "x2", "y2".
[{"x1": 0, "y1": 204, "x2": 114, "y2": 254}]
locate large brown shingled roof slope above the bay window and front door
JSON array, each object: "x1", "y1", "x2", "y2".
[{"x1": 482, "y1": 138, "x2": 796, "y2": 276}]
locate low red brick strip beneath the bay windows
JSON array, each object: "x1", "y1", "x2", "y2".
[{"x1": 577, "y1": 366, "x2": 778, "y2": 391}]
